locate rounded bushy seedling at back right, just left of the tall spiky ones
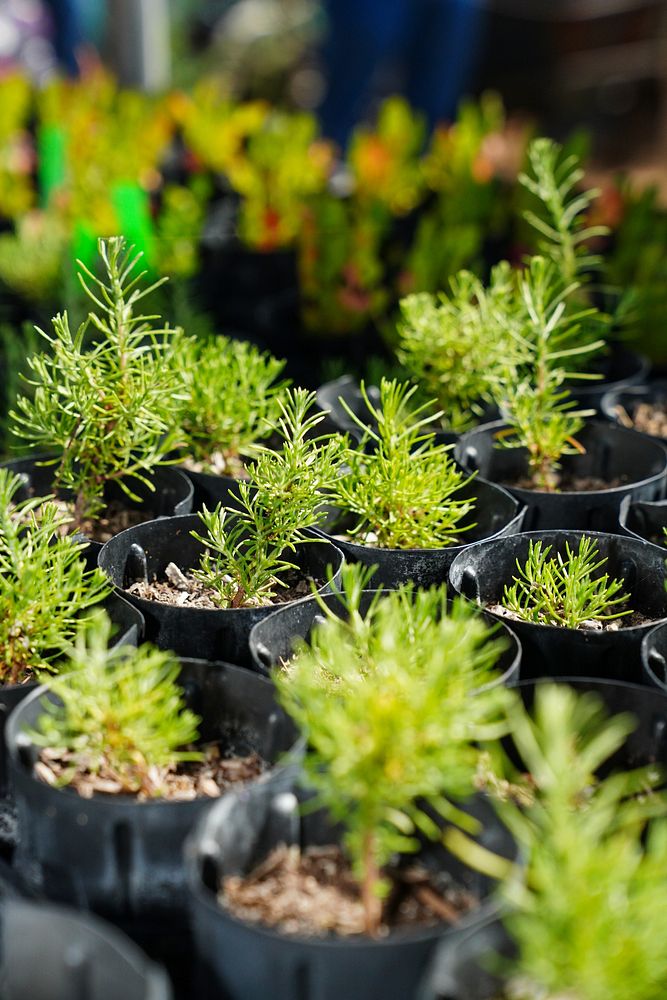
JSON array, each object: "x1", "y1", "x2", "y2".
[{"x1": 397, "y1": 263, "x2": 516, "y2": 431}]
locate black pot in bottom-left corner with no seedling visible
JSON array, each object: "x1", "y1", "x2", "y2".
[{"x1": 0, "y1": 899, "x2": 172, "y2": 1000}]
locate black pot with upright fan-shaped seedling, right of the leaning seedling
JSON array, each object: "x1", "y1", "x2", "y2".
[{"x1": 321, "y1": 379, "x2": 522, "y2": 587}]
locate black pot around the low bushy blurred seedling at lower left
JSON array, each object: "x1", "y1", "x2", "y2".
[{"x1": 7, "y1": 660, "x2": 297, "y2": 926}]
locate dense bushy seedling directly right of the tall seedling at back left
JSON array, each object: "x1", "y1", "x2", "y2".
[{"x1": 172, "y1": 335, "x2": 288, "y2": 477}]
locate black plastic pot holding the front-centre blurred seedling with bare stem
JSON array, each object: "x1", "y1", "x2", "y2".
[{"x1": 186, "y1": 770, "x2": 516, "y2": 1000}]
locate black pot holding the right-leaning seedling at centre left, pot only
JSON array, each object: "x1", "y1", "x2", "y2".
[{"x1": 99, "y1": 515, "x2": 343, "y2": 667}]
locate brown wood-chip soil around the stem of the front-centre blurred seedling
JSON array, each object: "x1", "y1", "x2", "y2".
[{"x1": 219, "y1": 844, "x2": 479, "y2": 937}]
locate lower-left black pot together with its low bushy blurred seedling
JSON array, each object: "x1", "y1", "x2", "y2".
[{"x1": 7, "y1": 615, "x2": 296, "y2": 931}]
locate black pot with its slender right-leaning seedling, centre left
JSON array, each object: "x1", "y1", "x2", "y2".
[{"x1": 100, "y1": 389, "x2": 346, "y2": 666}]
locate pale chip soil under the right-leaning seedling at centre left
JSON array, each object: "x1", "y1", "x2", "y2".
[{"x1": 127, "y1": 563, "x2": 324, "y2": 611}]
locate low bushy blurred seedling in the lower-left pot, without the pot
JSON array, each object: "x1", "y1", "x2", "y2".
[{"x1": 29, "y1": 613, "x2": 201, "y2": 797}]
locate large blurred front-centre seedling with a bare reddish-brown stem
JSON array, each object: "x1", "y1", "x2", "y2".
[{"x1": 275, "y1": 591, "x2": 512, "y2": 934}]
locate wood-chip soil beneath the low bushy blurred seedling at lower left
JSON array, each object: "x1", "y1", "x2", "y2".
[{"x1": 35, "y1": 744, "x2": 266, "y2": 802}]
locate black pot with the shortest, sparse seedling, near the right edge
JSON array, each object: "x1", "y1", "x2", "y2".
[{"x1": 450, "y1": 531, "x2": 667, "y2": 682}]
